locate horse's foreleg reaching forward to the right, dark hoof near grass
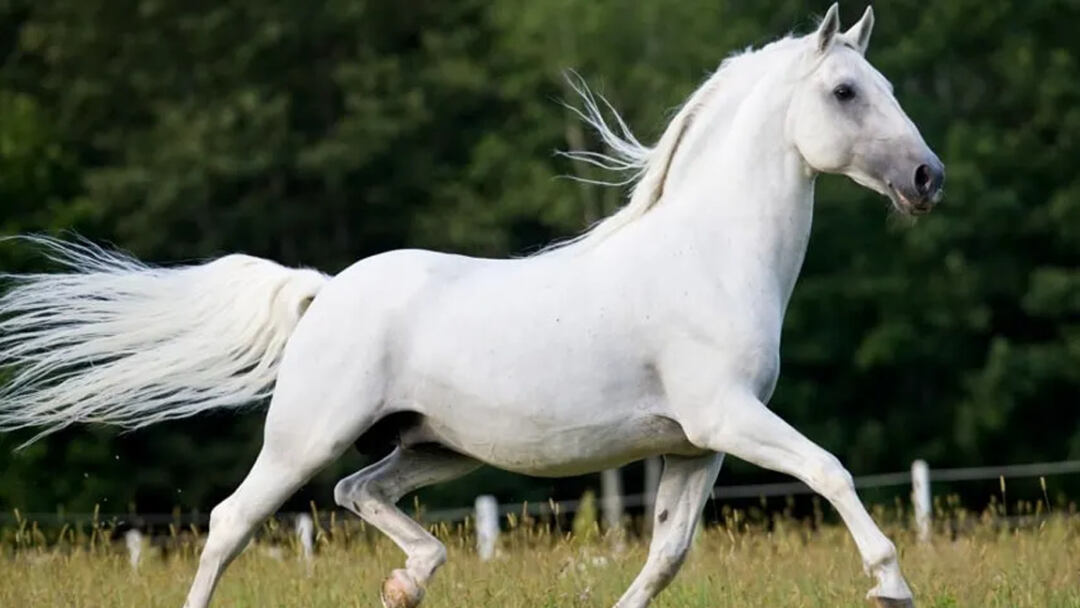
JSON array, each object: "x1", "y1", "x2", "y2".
[{"x1": 681, "y1": 395, "x2": 914, "y2": 607}]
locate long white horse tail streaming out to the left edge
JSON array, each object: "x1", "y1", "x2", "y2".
[{"x1": 0, "y1": 237, "x2": 328, "y2": 442}]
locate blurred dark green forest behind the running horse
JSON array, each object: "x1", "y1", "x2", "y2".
[{"x1": 0, "y1": 0, "x2": 1080, "y2": 513}]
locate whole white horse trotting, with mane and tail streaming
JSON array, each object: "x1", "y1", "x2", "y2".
[{"x1": 0, "y1": 5, "x2": 944, "y2": 608}]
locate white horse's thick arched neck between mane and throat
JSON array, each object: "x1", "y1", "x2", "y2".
[{"x1": 656, "y1": 75, "x2": 813, "y2": 314}]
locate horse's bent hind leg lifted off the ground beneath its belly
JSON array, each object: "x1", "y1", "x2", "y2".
[{"x1": 334, "y1": 446, "x2": 481, "y2": 608}]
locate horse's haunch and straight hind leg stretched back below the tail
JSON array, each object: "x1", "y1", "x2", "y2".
[{"x1": 185, "y1": 272, "x2": 406, "y2": 608}]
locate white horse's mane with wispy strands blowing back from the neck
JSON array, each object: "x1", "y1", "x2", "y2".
[{"x1": 549, "y1": 37, "x2": 804, "y2": 251}]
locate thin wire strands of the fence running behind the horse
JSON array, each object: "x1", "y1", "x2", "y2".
[{"x1": 0, "y1": 460, "x2": 1080, "y2": 527}]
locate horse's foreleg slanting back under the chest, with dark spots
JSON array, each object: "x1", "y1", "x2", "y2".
[{"x1": 616, "y1": 454, "x2": 724, "y2": 608}]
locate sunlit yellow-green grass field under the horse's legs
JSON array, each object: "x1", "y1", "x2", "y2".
[{"x1": 0, "y1": 509, "x2": 1080, "y2": 608}]
